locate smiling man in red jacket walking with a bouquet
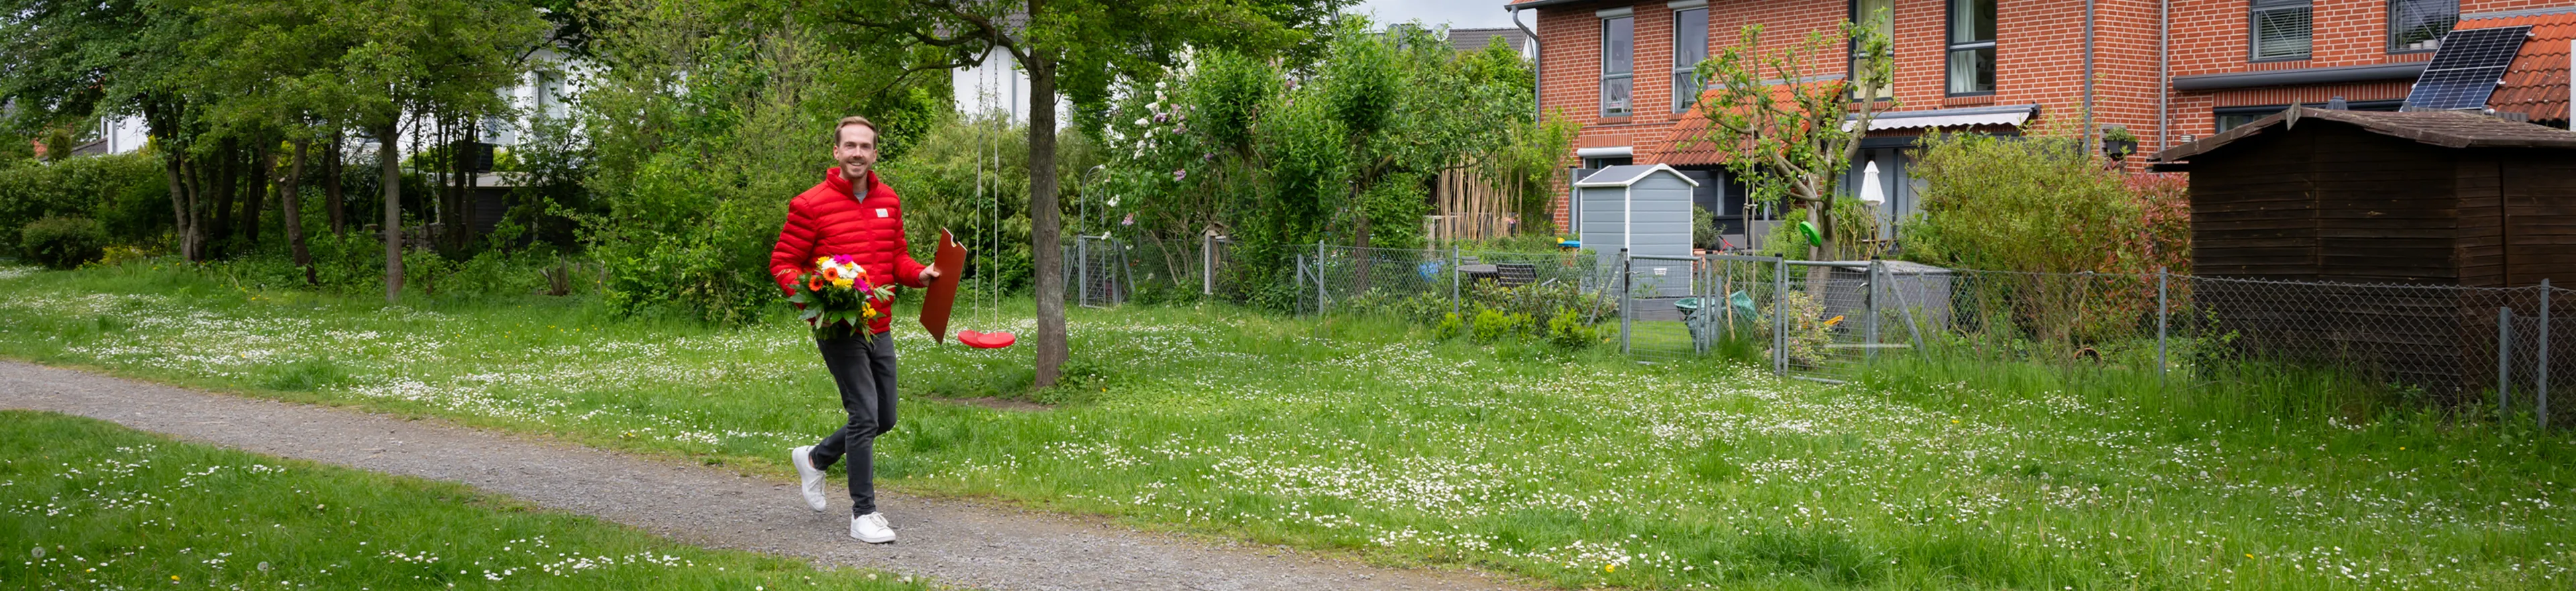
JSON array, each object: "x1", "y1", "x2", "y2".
[{"x1": 770, "y1": 116, "x2": 941, "y2": 545}]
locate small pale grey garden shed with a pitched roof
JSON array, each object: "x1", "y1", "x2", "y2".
[{"x1": 1574, "y1": 165, "x2": 1700, "y2": 297}]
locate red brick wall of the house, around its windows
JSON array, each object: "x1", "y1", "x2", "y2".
[{"x1": 1536, "y1": 0, "x2": 2576, "y2": 225}]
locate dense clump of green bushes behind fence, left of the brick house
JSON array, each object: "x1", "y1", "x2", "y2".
[{"x1": 1103, "y1": 18, "x2": 1571, "y2": 307}]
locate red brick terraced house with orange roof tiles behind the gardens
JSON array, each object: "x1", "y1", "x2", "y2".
[{"x1": 1505, "y1": 0, "x2": 2576, "y2": 245}]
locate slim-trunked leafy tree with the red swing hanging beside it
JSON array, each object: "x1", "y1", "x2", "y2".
[{"x1": 824, "y1": 0, "x2": 1350, "y2": 387}]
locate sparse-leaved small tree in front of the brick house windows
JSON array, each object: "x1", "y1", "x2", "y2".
[{"x1": 1695, "y1": 13, "x2": 1896, "y2": 256}]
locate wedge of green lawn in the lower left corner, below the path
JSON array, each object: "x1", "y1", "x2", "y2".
[{"x1": 0, "y1": 411, "x2": 925, "y2": 588}]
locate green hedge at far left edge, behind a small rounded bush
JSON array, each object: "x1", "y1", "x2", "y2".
[{"x1": 0, "y1": 152, "x2": 170, "y2": 256}]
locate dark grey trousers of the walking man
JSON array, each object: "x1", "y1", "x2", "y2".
[{"x1": 812, "y1": 333, "x2": 894, "y2": 516}]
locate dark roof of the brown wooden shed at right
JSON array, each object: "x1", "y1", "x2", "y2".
[{"x1": 2156, "y1": 106, "x2": 2576, "y2": 162}]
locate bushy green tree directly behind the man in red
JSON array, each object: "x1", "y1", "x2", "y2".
[{"x1": 574, "y1": 0, "x2": 951, "y2": 323}]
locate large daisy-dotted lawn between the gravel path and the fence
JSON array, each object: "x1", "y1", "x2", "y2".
[{"x1": 0, "y1": 266, "x2": 2576, "y2": 588}]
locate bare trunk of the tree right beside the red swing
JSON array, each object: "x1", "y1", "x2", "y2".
[{"x1": 1028, "y1": 48, "x2": 1071, "y2": 387}]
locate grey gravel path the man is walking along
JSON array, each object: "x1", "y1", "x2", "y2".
[{"x1": 0, "y1": 362, "x2": 1520, "y2": 591}]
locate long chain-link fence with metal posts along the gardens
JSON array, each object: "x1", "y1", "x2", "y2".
[{"x1": 1164, "y1": 235, "x2": 2576, "y2": 423}]
